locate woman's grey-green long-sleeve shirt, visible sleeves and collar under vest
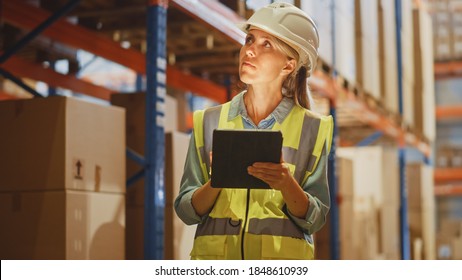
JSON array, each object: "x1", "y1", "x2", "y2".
[{"x1": 174, "y1": 92, "x2": 330, "y2": 234}]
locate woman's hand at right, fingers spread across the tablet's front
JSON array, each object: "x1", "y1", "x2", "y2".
[{"x1": 247, "y1": 162, "x2": 293, "y2": 191}]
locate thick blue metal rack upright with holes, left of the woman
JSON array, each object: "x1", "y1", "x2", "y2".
[{"x1": 144, "y1": 0, "x2": 168, "y2": 260}]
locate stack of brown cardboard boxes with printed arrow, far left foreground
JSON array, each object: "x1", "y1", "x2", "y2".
[{"x1": 0, "y1": 97, "x2": 125, "y2": 259}]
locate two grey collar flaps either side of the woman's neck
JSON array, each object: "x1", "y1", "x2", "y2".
[{"x1": 228, "y1": 90, "x2": 295, "y2": 123}]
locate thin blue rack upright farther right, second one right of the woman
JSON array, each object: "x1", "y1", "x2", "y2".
[{"x1": 395, "y1": 0, "x2": 411, "y2": 260}]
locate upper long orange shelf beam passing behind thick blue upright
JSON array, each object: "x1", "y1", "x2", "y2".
[{"x1": 2, "y1": 0, "x2": 227, "y2": 102}]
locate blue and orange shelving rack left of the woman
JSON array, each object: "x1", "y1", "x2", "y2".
[{"x1": 0, "y1": 0, "x2": 228, "y2": 259}]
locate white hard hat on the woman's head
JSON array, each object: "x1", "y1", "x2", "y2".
[{"x1": 238, "y1": 2, "x2": 319, "y2": 75}]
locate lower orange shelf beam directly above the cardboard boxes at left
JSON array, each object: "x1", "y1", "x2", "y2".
[{"x1": 2, "y1": 56, "x2": 114, "y2": 100}]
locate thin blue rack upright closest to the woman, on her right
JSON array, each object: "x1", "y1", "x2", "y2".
[{"x1": 327, "y1": 0, "x2": 340, "y2": 260}]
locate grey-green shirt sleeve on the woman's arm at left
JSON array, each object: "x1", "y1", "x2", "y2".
[{"x1": 174, "y1": 132, "x2": 206, "y2": 225}]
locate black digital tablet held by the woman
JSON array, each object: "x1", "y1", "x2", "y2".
[{"x1": 211, "y1": 129, "x2": 282, "y2": 189}]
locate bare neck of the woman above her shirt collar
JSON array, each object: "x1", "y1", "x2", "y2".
[{"x1": 244, "y1": 87, "x2": 282, "y2": 125}]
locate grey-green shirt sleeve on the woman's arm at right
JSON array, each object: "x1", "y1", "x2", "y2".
[{"x1": 287, "y1": 147, "x2": 330, "y2": 234}]
